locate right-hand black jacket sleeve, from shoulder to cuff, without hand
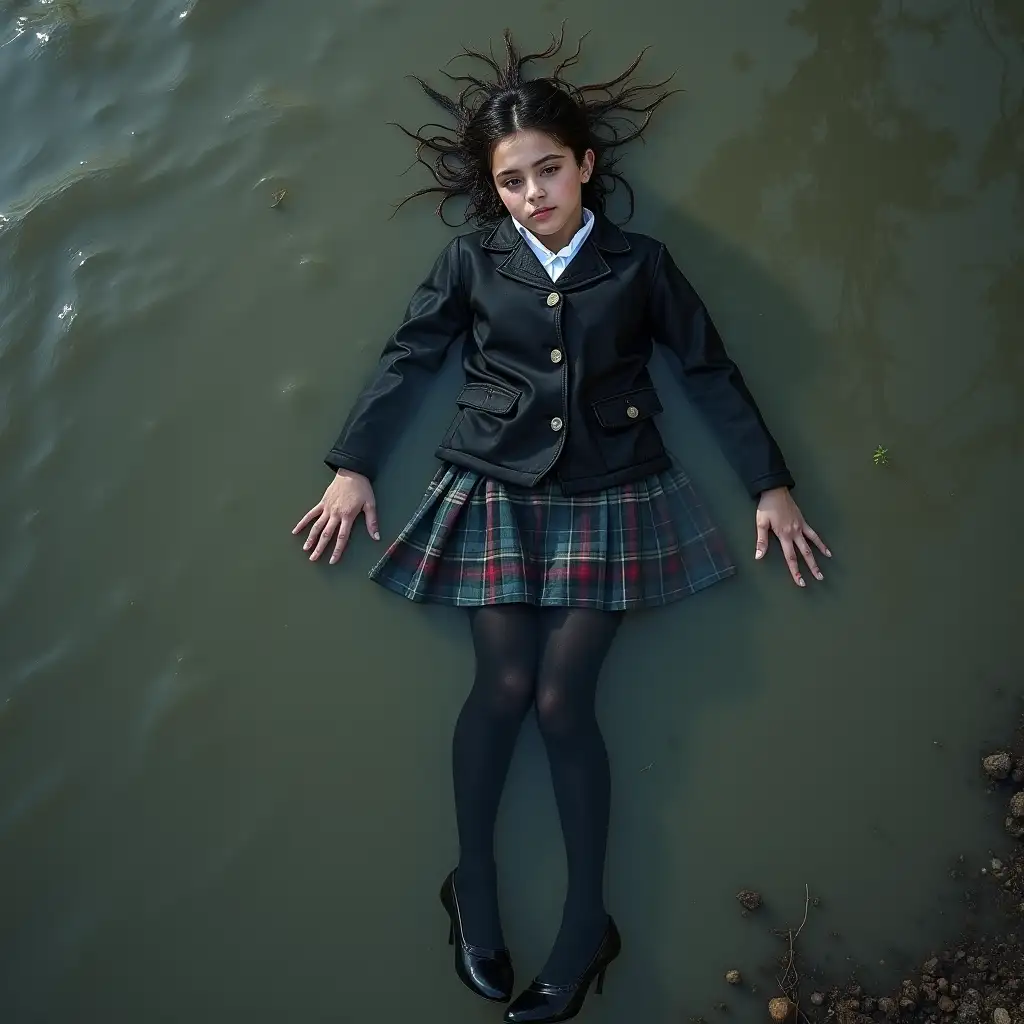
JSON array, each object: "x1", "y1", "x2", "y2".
[{"x1": 649, "y1": 245, "x2": 794, "y2": 498}]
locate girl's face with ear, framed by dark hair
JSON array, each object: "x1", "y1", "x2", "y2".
[{"x1": 490, "y1": 130, "x2": 594, "y2": 252}]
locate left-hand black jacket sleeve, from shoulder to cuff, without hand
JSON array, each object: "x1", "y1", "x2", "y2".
[{"x1": 324, "y1": 238, "x2": 471, "y2": 479}]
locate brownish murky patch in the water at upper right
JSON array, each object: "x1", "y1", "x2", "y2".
[{"x1": 696, "y1": 0, "x2": 963, "y2": 532}]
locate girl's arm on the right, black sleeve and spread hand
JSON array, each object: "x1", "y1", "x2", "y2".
[{"x1": 649, "y1": 246, "x2": 831, "y2": 587}]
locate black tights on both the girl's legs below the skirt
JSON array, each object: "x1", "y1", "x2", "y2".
[{"x1": 452, "y1": 604, "x2": 623, "y2": 984}]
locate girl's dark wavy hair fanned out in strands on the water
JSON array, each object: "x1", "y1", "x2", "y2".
[{"x1": 391, "y1": 25, "x2": 679, "y2": 226}]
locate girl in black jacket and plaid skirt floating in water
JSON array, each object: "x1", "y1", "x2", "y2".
[{"x1": 294, "y1": 33, "x2": 829, "y2": 1022}]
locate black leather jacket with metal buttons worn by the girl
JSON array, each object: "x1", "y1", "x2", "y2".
[{"x1": 325, "y1": 214, "x2": 793, "y2": 497}]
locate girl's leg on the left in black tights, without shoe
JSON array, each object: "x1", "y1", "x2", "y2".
[{"x1": 452, "y1": 604, "x2": 539, "y2": 949}]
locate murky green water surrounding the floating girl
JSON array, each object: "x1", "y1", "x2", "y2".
[{"x1": 0, "y1": 0, "x2": 1024, "y2": 1024}]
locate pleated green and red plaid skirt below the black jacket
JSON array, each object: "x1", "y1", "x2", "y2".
[{"x1": 370, "y1": 463, "x2": 736, "y2": 610}]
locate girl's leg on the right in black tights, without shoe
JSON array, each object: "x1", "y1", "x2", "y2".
[{"x1": 537, "y1": 608, "x2": 624, "y2": 984}]
